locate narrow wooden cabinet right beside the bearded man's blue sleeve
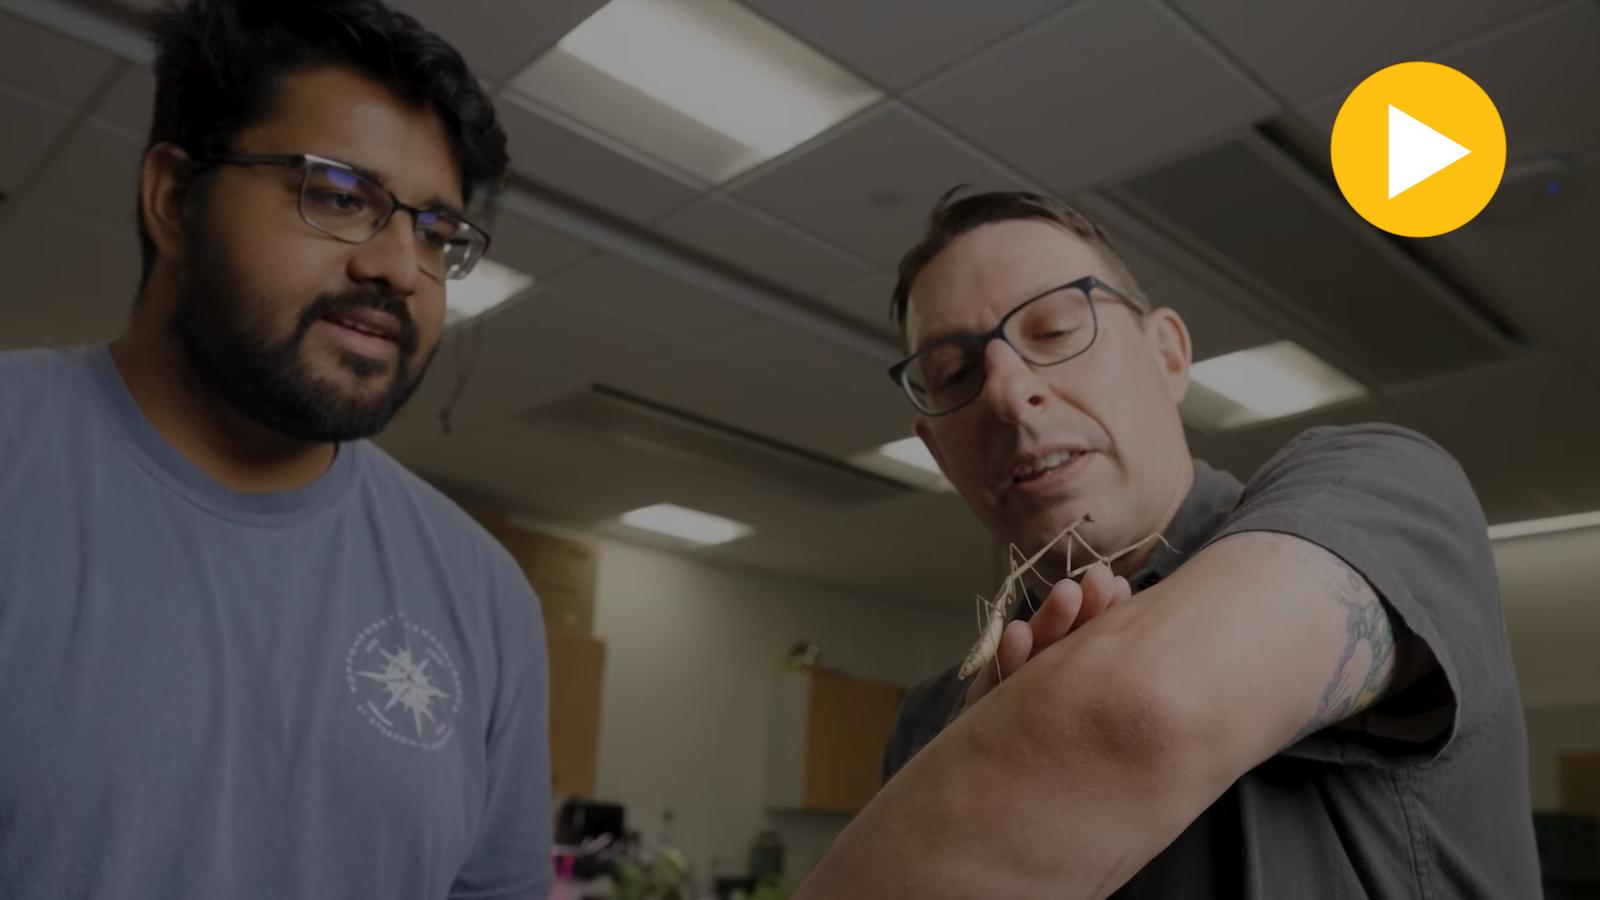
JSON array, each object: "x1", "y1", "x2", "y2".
[{"x1": 547, "y1": 629, "x2": 605, "y2": 796}]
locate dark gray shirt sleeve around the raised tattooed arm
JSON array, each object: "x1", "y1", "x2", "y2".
[{"x1": 1211, "y1": 424, "x2": 1515, "y2": 765}]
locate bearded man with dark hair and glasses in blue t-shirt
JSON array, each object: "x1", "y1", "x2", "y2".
[{"x1": 0, "y1": 0, "x2": 552, "y2": 900}]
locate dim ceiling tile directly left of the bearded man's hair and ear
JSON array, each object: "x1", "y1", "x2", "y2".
[{"x1": 30, "y1": 125, "x2": 144, "y2": 234}]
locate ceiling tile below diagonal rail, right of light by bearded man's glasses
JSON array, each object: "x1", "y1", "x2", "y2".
[{"x1": 555, "y1": 255, "x2": 765, "y2": 340}]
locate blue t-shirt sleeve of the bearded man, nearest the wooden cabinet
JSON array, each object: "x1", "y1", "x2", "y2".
[{"x1": 450, "y1": 548, "x2": 555, "y2": 900}]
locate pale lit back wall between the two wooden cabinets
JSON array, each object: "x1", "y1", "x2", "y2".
[{"x1": 579, "y1": 541, "x2": 974, "y2": 884}]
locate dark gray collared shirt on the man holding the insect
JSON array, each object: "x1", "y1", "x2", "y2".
[{"x1": 883, "y1": 424, "x2": 1541, "y2": 900}]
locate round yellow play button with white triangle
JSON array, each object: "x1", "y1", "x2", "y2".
[{"x1": 1331, "y1": 62, "x2": 1506, "y2": 237}]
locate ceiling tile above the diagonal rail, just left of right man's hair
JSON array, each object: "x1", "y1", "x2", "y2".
[{"x1": 658, "y1": 197, "x2": 869, "y2": 295}]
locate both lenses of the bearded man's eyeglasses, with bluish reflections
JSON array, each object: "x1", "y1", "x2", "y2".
[{"x1": 301, "y1": 163, "x2": 482, "y2": 279}]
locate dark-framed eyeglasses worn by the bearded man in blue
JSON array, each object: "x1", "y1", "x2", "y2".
[{"x1": 197, "y1": 154, "x2": 490, "y2": 280}]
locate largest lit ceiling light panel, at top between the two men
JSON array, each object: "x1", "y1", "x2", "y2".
[{"x1": 510, "y1": 0, "x2": 883, "y2": 184}]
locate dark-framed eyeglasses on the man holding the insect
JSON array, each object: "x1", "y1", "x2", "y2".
[{"x1": 890, "y1": 275, "x2": 1144, "y2": 416}]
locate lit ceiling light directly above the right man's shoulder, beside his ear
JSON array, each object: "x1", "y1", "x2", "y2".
[{"x1": 1182, "y1": 341, "x2": 1366, "y2": 431}]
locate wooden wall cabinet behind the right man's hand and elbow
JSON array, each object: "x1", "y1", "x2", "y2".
[{"x1": 766, "y1": 671, "x2": 904, "y2": 814}]
